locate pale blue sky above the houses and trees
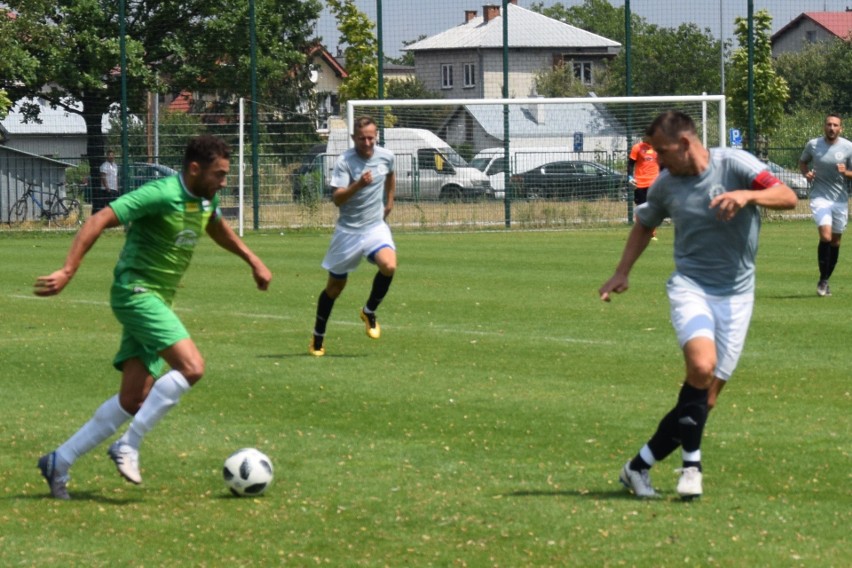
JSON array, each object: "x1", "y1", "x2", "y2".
[{"x1": 317, "y1": 0, "x2": 852, "y2": 56}]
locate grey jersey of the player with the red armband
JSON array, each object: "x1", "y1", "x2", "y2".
[{"x1": 636, "y1": 148, "x2": 774, "y2": 296}]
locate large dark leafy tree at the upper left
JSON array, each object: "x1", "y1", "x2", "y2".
[{"x1": 4, "y1": 0, "x2": 321, "y2": 189}]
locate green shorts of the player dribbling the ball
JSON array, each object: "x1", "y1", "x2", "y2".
[{"x1": 110, "y1": 284, "x2": 189, "y2": 377}]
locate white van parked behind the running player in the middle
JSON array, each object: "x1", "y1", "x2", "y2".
[{"x1": 325, "y1": 128, "x2": 491, "y2": 201}]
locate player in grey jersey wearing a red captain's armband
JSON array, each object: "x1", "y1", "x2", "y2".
[{"x1": 599, "y1": 111, "x2": 796, "y2": 499}]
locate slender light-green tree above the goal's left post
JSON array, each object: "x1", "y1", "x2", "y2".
[{"x1": 328, "y1": 0, "x2": 379, "y2": 103}]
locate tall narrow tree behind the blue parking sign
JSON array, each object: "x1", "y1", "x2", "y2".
[{"x1": 726, "y1": 9, "x2": 790, "y2": 142}]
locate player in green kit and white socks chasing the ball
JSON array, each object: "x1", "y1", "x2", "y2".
[{"x1": 35, "y1": 136, "x2": 272, "y2": 499}]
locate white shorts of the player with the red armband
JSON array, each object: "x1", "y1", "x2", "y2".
[{"x1": 666, "y1": 280, "x2": 754, "y2": 381}]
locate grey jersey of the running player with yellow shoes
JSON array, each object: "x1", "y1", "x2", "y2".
[{"x1": 331, "y1": 146, "x2": 394, "y2": 232}]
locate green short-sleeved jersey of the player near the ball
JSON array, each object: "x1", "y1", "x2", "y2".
[{"x1": 109, "y1": 175, "x2": 219, "y2": 304}]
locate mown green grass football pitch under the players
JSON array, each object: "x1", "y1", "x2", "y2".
[{"x1": 0, "y1": 221, "x2": 852, "y2": 567}]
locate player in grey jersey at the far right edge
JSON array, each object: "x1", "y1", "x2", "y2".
[{"x1": 799, "y1": 114, "x2": 852, "y2": 296}]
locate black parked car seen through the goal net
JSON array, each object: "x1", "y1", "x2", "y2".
[{"x1": 512, "y1": 160, "x2": 630, "y2": 200}]
